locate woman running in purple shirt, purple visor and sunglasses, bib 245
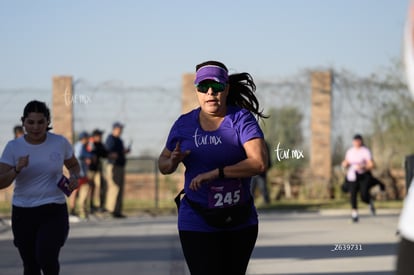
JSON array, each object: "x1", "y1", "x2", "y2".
[{"x1": 159, "y1": 61, "x2": 268, "y2": 275}]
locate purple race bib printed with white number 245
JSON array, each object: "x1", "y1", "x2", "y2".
[{"x1": 208, "y1": 180, "x2": 245, "y2": 208}]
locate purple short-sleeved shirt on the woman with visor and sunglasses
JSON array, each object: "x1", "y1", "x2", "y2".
[{"x1": 166, "y1": 106, "x2": 263, "y2": 232}]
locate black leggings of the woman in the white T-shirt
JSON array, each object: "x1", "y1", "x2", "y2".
[{"x1": 12, "y1": 204, "x2": 69, "y2": 275}]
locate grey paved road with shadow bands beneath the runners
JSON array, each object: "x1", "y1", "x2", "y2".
[{"x1": 0, "y1": 209, "x2": 398, "y2": 275}]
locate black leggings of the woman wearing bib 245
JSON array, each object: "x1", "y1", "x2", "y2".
[{"x1": 180, "y1": 225, "x2": 258, "y2": 275}]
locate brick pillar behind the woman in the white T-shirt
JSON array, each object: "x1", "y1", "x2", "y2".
[{"x1": 52, "y1": 76, "x2": 74, "y2": 143}]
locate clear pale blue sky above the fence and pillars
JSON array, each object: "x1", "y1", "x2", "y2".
[{"x1": 0, "y1": 0, "x2": 408, "y2": 89}]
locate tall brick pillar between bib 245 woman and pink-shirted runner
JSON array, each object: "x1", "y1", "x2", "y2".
[{"x1": 310, "y1": 71, "x2": 332, "y2": 197}]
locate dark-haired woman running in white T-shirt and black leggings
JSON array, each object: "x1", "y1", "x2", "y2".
[{"x1": 0, "y1": 100, "x2": 80, "y2": 275}]
